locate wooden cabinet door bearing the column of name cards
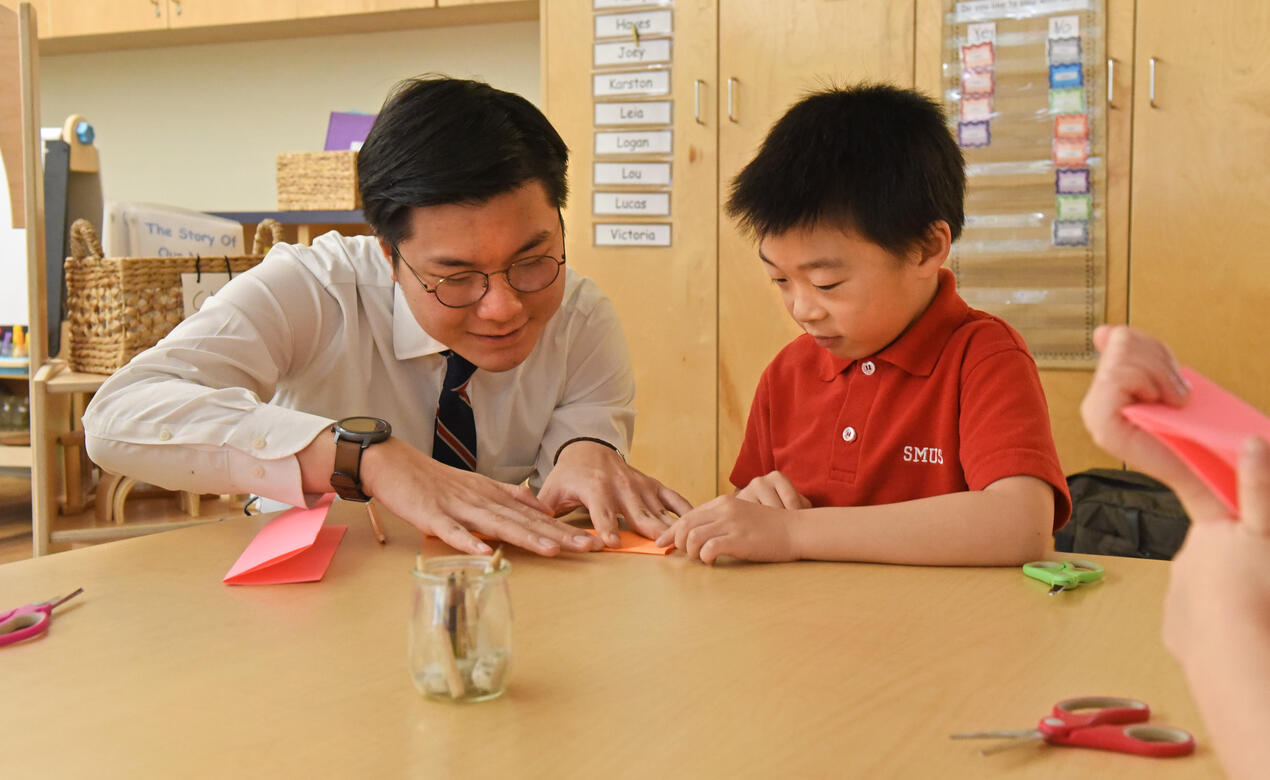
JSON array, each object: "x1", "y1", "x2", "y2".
[{"x1": 541, "y1": 0, "x2": 719, "y2": 502}]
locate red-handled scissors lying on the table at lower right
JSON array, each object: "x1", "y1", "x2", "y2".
[{"x1": 953, "y1": 696, "x2": 1195, "y2": 758}]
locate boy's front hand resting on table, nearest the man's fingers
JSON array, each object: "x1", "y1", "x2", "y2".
[{"x1": 657, "y1": 495, "x2": 799, "y2": 564}]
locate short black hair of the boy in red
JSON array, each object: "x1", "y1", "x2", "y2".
[{"x1": 728, "y1": 84, "x2": 965, "y2": 254}]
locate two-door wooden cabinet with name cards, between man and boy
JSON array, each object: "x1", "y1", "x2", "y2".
[{"x1": 541, "y1": 0, "x2": 914, "y2": 502}]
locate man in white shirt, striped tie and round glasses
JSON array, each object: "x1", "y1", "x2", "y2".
[{"x1": 84, "y1": 79, "x2": 691, "y2": 555}]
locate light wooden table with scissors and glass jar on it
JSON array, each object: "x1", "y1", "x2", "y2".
[{"x1": 0, "y1": 504, "x2": 1220, "y2": 779}]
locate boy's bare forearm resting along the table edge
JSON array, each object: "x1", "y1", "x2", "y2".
[{"x1": 791, "y1": 478, "x2": 1054, "y2": 567}]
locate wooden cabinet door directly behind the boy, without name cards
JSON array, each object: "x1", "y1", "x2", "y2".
[{"x1": 719, "y1": 0, "x2": 913, "y2": 490}]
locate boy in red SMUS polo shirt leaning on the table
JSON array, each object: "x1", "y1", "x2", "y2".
[{"x1": 658, "y1": 85, "x2": 1072, "y2": 565}]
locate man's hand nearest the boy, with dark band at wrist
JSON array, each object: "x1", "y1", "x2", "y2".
[{"x1": 538, "y1": 441, "x2": 692, "y2": 548}]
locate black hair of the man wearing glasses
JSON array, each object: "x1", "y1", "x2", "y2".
[{"x1": 357, "y1": 76, "x2": 569, "y2": 246}]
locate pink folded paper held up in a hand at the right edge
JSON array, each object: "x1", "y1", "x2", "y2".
[{"x1": 1123, "y1": 366, "x2": 1270, "y2": 514}]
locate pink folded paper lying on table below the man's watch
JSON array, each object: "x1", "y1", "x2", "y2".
[{"x1": 221, "y1": 497, "x2": 348, "y2": 584}]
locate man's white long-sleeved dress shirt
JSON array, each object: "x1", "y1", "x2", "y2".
[{"x1": 84, "y1": 232, "x2": 635, "y2": 506}]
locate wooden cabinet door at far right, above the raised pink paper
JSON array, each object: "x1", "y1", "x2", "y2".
[{"x1": 1129, "y1": 0, "x2": 1270, "y2": 409}]
